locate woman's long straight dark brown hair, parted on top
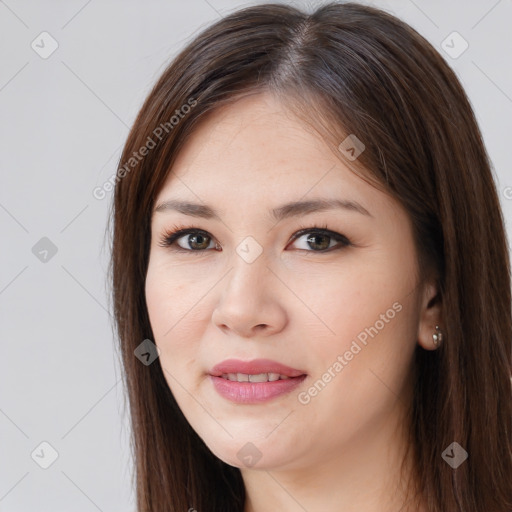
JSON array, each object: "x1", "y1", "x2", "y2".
[{"x1": 111, "y1": 3, "x2": 512, "y2": 512}]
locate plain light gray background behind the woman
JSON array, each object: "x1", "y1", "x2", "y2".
[{"x1": 0, "y1": 0, "x2": 512, "y2": 512}]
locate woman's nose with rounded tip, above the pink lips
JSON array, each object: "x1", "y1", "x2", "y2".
[{"x1": 212, "y1": 256, "x2": 288, "y2": 338}]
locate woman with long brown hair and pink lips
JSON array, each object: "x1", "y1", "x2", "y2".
[{"x1": 112, "y1": 3, "x2": 512, "y2": 512}]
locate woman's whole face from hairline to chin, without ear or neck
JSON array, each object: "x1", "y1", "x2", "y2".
[{"x1": 146, "y1": 94, "x2": 430, "y2": 469}]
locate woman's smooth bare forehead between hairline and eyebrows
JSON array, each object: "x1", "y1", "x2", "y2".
[{"x1": 157, "y1": 93, "x2": 397, "y2": 226}]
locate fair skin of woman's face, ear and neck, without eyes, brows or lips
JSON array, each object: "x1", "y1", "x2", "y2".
[{"x1": 146, "y1": 93, "x2": 442, "y2": 512}]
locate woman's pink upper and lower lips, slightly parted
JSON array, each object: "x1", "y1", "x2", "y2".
[{"x1": 209, "y1": 359, "x2": 307, "y2": 404}]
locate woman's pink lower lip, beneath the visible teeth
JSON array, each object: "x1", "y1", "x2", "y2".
[{"x1": 210, "y1": 375, "x2": 306, "y2": 404}]
